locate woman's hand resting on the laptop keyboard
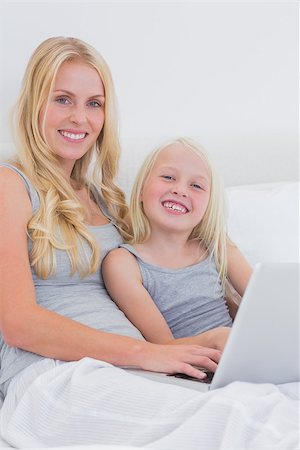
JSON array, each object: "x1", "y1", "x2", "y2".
[{"x1": 139, "y1": 344, "x2": 221, "y2": 379}]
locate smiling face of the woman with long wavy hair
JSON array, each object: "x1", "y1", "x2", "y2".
[{"x1": 39, "y1": 61, "x2": 105, "y2": 174}]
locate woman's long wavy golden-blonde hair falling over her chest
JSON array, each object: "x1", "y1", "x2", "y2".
[{"x1": 14, "y1": 37, "x2": 128, "y2": 278}]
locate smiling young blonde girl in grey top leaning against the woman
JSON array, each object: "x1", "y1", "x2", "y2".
[{"x1": 102, "y1": 139, "x2": 251, "y2": 350}]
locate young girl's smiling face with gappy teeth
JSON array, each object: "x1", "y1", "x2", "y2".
[{"x1": 141, "y1": 144, "x2": 210, "y2": 236}]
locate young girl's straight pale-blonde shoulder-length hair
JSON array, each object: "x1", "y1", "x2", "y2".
[{"x1": 129, "y1": 138, "x2": 230, "y2": 285}]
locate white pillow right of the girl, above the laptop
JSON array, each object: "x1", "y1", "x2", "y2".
[{"x1": 226, "y1": 182, "x2": 299, "y2": 266}]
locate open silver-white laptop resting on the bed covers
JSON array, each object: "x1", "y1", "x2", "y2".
[{"x1": 126, "y1": 263, "x2": 300, "y2": 392}]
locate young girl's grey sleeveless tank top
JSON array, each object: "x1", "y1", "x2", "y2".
[{"x1": 120, "y1": 244, "x2": 232, "y2": 338}]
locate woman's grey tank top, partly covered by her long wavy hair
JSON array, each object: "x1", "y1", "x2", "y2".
[{"x1": 0, "y1": 163, "x2": 143, "y2": 395}]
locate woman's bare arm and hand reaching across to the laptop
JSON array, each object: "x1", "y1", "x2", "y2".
[{"x1": 0, "y1": 167, "x2": 220, "y2": 377}]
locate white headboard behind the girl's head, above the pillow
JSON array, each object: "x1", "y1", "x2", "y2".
[{"x1": 0, "y1": 135, "x2": 299, "y2": 199}]
